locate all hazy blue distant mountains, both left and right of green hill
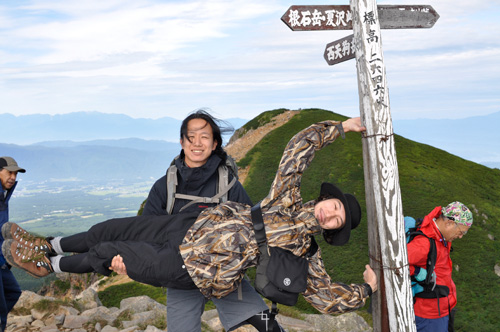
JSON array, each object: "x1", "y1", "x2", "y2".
[{"x1": 0, "y1": 112, "x2": 500, "y2": 174}]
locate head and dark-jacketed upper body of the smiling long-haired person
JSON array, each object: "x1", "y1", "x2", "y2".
[{"x1": 142, "y1": 110, "x2": 252, "y2": 217}]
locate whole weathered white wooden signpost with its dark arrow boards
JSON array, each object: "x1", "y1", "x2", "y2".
[{"x1": 282, "y1": 0, "x2": 439, "y2": 332}]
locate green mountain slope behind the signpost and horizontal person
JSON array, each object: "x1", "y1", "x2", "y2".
[{"x1": 239, "y1": 109, "x2": 500, "y2": 331}]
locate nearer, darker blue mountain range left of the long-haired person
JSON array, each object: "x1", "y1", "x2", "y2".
[{"x1": 0, "y1": 138, "x2": 180, "y2": 183}]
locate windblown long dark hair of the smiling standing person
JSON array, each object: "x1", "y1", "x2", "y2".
[{"x1": 180, "y1": 109, "x2": 234, "y2": 161}]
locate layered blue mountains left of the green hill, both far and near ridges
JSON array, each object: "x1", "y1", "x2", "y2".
[{"x1": 0, "y1": 112, "x2": 247, "y2": 183}]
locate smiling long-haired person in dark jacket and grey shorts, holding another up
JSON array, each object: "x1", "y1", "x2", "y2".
[{"x1": 137, "y1": 110, "x2": 280, "y2": 332}]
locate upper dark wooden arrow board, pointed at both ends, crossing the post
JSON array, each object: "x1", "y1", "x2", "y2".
[{"x1": 281, "y1": 5, "x2": 439, "y2": 31}]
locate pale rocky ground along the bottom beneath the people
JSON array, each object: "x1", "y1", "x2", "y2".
[{"x1": 6, "y1": 287, "x2": 372, "y2": 332}]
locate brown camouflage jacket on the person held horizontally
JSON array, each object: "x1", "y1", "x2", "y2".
[{"x1": 180, "y1": 121, "x2": 370, "y2": 313}]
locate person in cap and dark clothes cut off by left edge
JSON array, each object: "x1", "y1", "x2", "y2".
[{"x1": 0, "y1": 157, "x2": 26, "y2": 332}]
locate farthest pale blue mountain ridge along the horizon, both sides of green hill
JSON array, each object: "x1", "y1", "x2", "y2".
[{"x1": 0, "y1": 112, "x2": 500, "y2": 168}]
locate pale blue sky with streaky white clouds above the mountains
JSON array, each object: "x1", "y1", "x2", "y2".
[{"x1": 0, "y1": 0, "x2": 500, "y2": 119}]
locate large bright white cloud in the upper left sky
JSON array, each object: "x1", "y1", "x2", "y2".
[{"x1": 2, "y1": 1, "x2": 278, "y2": 64}]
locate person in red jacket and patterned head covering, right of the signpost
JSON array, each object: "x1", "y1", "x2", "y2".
[{"x1": 407, "y1": 202, "x2": 472, "y2": 332}]
